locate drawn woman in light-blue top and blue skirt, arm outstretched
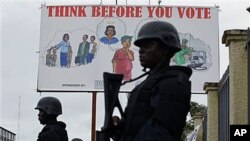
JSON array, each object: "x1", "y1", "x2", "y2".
[{"x1": 51, "y1": 33, "x2": 71, "y2": 67}]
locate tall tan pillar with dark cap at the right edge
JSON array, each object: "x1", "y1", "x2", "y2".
[{"x1": 222, "y1": 30, "x2": 248, "y2": 124}]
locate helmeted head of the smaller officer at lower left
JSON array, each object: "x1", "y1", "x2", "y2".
[{"x1": 35, "y1": 97, "x2": 62, "y2": 124}]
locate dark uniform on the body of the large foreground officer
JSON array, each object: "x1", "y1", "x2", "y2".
[{"x1": 119, "y1": 67, "x2": 192, "y2": 141}]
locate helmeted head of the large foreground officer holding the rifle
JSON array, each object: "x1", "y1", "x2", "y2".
[{"x1": 134, "y1": 21, "x2": 181, "y2": 69}]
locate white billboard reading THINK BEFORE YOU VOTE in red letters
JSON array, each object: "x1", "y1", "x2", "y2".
[{"x1": 37, "y1": 5, "x2": 219, "y2": 93}]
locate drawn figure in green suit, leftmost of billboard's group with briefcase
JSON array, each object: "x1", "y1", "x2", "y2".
[{"x1": 77, "y1": 34, "x2": 90, "y2": 65}]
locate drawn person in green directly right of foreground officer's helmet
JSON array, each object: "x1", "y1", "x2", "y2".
[{"x1": 174, "y1": 39, "x2": 193, "y2": 65}]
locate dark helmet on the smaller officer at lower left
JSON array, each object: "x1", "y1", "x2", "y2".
[{"x1": 35, "y1": 97, "x2": 62, "y2": 115}]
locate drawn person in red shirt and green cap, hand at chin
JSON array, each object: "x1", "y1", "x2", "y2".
[{"x1": 112, "y1": 35, "x2": 134, "y2": 80}]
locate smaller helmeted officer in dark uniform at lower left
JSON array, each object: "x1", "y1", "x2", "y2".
[{"x1": 35, "y1": 97, "x2": 68, "y2": 141}]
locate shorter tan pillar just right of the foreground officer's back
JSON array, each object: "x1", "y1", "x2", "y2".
[{"x1": 203, "y1": 82, "x2": 219, "y2": 141}]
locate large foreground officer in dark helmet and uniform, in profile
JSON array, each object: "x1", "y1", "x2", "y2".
[{"x1": 119, "y1": 21, "x2": 192, "y2": 141}]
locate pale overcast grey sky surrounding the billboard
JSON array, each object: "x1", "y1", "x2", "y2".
[{"x1": 0, "y1": 0, "x2": 250, "y2": 141}]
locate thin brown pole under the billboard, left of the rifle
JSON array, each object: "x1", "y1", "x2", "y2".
[{"x1": 91, "y1": 91, "x2": 96, "y2": 141}]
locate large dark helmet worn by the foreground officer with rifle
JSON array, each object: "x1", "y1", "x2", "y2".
[{"x1": 134, "y1": 21, "x2": 181, "y2": 52}]
